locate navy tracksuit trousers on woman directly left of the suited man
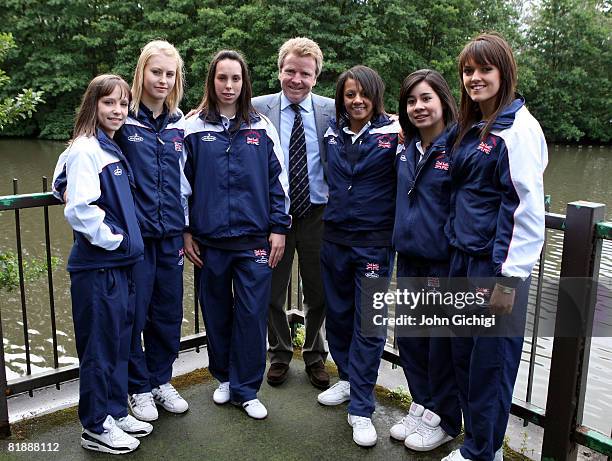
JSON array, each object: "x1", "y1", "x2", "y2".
[{"x1": 199, "y1": 245, "x2": 272, "y2": 403}]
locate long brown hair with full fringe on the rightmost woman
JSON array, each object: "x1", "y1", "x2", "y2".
[{"x1": 455, "y1": 32, "x2": 517, "y2": 147}]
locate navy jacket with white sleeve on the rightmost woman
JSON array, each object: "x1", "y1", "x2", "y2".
[{"x1": 446, "y1": 98, "x2": 548, "y2": 285}]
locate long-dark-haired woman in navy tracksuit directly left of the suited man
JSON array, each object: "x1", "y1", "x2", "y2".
[{"x1": 184, "y1": 50, "x2": 291, "y2": 419}]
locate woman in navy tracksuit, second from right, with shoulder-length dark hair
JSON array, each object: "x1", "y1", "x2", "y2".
[{"x1": 390, "y1": 69, "x2": 461, "y2": 451}]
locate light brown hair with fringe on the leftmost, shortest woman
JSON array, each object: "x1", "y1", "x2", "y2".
[{"x1": 72, "y1": 74, "x2": 130, "y2": 139}]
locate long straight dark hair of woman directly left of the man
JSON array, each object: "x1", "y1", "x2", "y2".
[{"x1": 196, "y1": 50, "x2": 255, "y2": 124}]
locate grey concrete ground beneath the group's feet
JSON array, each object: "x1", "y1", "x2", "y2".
[{"x1": 0, "y1": 360, "x2": 468, "y2": 461}]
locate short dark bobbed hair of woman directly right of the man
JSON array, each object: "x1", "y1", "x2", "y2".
[{"x1": 336, "y1": 65, "x2": 385, "y2": 126}]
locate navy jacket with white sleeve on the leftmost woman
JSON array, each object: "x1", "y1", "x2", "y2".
[{"x1": 53, "y1": 130, "x2": 144, "y2": 271}]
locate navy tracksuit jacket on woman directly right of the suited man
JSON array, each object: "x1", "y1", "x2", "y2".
[{"x1": 323, "y1": 115, "x2": 400, "y2": 247}]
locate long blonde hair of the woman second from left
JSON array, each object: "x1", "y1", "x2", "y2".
[{"x1": 130, "y1": 40, "x2": 185, "y2": 113}]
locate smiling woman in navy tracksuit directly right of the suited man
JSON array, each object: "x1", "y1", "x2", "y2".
[{"x1": 318, "y1": 66, "x2": 399, "y2": 446}]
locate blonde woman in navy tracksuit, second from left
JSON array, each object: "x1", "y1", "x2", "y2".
[{"x1": 116, "y1": 40, "x2": 191, "y2": 421}]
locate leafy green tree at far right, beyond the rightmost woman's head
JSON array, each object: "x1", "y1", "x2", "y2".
[{"x1": 525, "y1": 0, "x2": 612, "y2": 142}]
